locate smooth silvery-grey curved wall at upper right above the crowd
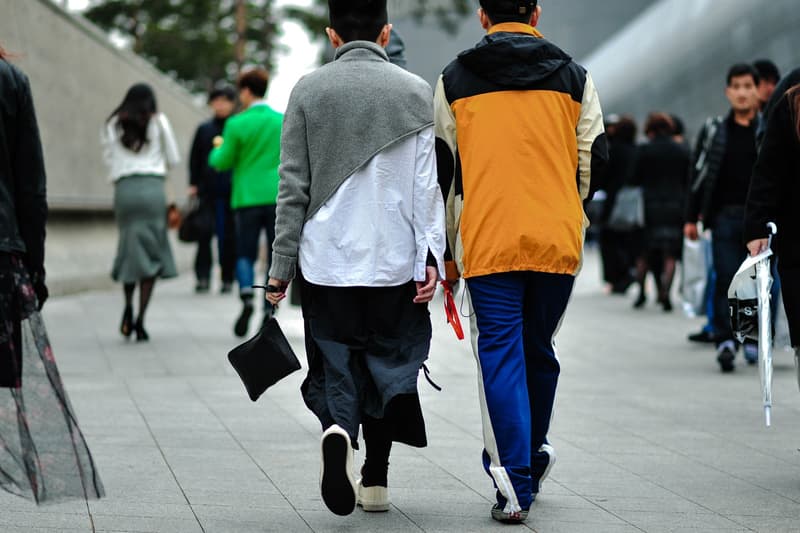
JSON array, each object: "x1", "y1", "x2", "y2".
[{"x1": 586, "y1": 0, "x2": 800, "y2": 139}]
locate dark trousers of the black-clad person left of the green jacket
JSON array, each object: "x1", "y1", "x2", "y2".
[{"x1": 194, "y1": 198, "x2": 236, "y2": 283}]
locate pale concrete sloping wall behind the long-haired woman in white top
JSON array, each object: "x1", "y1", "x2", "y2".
[{"x1": 0, "y1": 0, "x2": 205, "y2": 210}]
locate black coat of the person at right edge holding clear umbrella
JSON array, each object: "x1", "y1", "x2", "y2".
[{"x1": 745, "y1": 90, "x2": 800, "y2": 268}]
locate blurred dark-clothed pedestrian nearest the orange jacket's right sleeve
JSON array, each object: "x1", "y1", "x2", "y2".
[{"x1": 599, "y1": 115, "x2": 636, "y2": 294}]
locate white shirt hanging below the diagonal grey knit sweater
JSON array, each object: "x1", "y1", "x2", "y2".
[{"x1": 299, "y1": 127, "x2": 445, "y2": 287}]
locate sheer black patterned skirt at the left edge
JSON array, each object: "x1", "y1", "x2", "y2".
[{"x1": 0, "y1": 254, "x2": 104, "y2": 503}]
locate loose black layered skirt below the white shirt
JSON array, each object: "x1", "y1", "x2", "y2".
[{"x1": 298, "y1": 279, "x2": 431, "y2": 447}]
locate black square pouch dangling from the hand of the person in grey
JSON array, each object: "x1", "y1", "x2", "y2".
[{"x1": 228, "y1": 318, "x2": 301, "y2": 401}]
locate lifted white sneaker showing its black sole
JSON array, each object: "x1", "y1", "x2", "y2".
[{"x1": 319, "y1": 424, "x2": 357, "y2": 516}]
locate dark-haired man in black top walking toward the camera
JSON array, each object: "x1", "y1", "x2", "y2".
[{"x1": 684, "y1": 64, "x2": 759, "y2": 372}]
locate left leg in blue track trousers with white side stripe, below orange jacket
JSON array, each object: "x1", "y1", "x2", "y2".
[{"x1": 467, "y1": 273, "x2": 533, "y2": 513}]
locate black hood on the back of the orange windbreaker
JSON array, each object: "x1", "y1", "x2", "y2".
[{"x1": 458, "y1": 31, "x2": 572, "y2": 87}]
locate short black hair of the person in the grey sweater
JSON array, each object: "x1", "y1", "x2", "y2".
[{"x1": 328, "y1": 0, "x2": 389, "y2": 43}]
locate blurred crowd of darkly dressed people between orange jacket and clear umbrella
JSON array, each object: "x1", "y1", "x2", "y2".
[{"x1": 587, "y1": 59, "x2": 798, "y2": 372}]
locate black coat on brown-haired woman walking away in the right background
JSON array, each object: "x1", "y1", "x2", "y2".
[{"x1": 632, "y1": 136, "x2": 691, "y2": 229}]
